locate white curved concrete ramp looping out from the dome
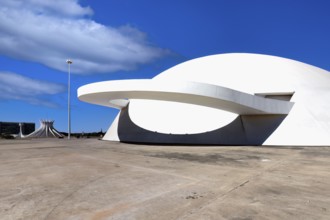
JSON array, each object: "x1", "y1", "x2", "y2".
[{"x1": 78, "y1": 79, "x2": 294, "y2": 115}]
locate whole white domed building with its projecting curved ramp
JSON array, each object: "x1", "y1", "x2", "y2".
[{"x1": 78, "y1": 53, "x2": 330, "y2": 146}]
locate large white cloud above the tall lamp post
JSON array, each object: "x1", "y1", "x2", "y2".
[{"x1": 0, "y1": 0, "x2": 168, "y2": 74}]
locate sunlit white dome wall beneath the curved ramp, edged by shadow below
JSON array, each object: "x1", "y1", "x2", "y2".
[{"x1": 129, "y1": 99, "x2": 237, "y2": 134}]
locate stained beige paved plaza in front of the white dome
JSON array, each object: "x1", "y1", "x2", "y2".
[{"x1": 0, "y1": 139, "x2": 330, "y2": 220}]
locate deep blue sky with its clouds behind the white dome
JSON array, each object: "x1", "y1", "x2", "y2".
[{"x1": 0, "y1": 0, "x2": 330, "y2": 132}]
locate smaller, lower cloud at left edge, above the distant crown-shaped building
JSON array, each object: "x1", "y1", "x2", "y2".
[{"x1": 0, "y1": 72, "x2": 65, "y2": 107}]
